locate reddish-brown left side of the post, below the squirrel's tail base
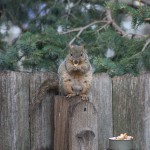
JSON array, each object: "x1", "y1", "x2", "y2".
[{"x1": 54, "y1": 96, "x2": 69, "y2": 150}]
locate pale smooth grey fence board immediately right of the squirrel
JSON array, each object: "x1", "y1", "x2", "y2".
[{"x1": 89, "y1": 74, "x2": 113, "y2": 150}]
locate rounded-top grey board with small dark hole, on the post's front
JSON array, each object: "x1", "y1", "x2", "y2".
[{"x1": 69, "y1": 101, "x2": 98, "y2": 150}]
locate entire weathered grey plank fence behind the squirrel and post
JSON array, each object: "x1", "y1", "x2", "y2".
[{"x1": 0, "y1": 71, "x2": 150, "y2": 150}]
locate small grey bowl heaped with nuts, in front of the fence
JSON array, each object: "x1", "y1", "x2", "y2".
[{"x1": 109, "y1": 133, "x2": 133, "y2": 150}]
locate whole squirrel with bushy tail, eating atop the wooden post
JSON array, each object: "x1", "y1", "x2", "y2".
[{"x1": 32, "y1": 45, "x2": 93, "y2": 111}]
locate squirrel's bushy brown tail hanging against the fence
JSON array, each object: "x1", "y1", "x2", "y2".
[{"x1": 30, "y1": 74, "x2": 59, "y2": 113}]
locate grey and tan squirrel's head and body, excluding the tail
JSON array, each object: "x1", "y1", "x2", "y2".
[{"x1": 58, "y1": 45, "x2": 93, "y2": 100}]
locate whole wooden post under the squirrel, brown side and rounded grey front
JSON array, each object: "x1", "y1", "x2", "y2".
[{"x1": 54, "y1": 96, "x2": 98, "y2": 150}]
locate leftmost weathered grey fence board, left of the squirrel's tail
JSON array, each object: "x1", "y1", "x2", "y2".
[{"x1": 0, "y1": 72, "x2": 30, "y2": 150}]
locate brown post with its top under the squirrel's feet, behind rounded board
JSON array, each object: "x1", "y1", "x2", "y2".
[{"x1": 54, "y1": 96, "x2": 81, "y2": 150}]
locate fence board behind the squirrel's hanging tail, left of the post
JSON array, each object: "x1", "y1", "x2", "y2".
[{"x1": 30, "y1": 73, "x2": 54, "y2": 150}]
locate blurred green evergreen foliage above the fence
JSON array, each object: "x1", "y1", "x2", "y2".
[{"x1": 0, "y1": 0, "x2": 150, "y2": 76}]
